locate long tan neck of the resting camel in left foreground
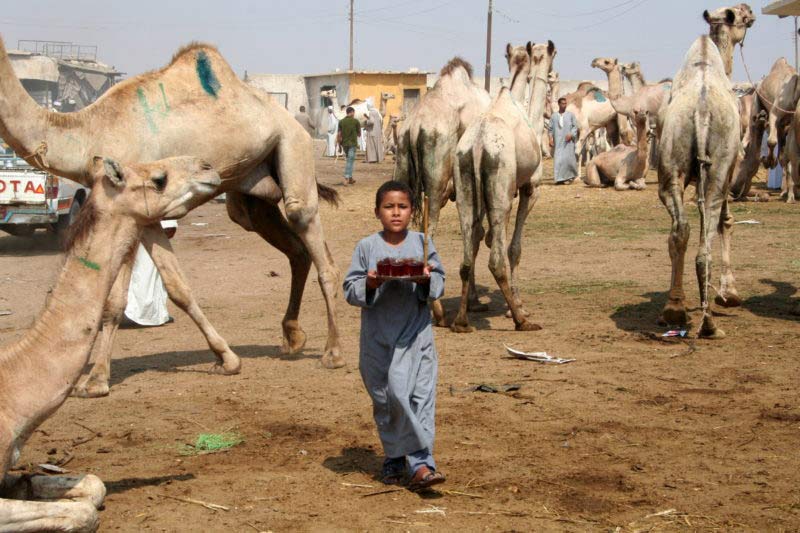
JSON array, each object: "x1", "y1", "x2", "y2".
[{"x1": 0, "y1": 206, "x2": 138, "y2": 440}]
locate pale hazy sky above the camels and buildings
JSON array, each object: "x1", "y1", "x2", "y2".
[{"x1": 0, "y1": 0, "x2": 794, "y2": 81}]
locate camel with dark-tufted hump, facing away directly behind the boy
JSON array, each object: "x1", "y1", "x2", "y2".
[{"x1": 394, "y1": 57, "x2": 491, "y2": 327}]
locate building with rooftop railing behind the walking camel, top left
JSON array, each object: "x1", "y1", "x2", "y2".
[{"x1": 8, "y1": 41, "x2": 123, "y2": 112}]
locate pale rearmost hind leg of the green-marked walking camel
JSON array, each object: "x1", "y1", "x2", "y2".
[{"x1": 275, "y1": 136, "x2": 345, "y2": 368}]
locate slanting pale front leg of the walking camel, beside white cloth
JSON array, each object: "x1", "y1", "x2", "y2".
[{"x1": 142, "y1": 224, "x2": 242, "y2": 375}]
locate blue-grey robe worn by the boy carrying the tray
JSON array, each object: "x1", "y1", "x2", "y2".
[{"x1": 344, "y1": 231, "x2": 444, "y2": 457}]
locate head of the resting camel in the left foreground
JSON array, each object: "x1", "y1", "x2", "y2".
[{"x1": 90, "y1": 156, "x2": 222, "y2": 225}]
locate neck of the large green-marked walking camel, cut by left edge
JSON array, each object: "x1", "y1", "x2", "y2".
[{"x1": 0, "y1": 39, "x2": 88, "y2": 183}]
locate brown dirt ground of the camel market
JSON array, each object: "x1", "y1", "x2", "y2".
[{"x1": 0, "y1": 151, "x2": 800, "y2": 531}]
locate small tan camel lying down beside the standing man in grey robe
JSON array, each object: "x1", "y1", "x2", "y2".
[{"x1": 584, "y1": 111, "x2": 651, "y2": 191}]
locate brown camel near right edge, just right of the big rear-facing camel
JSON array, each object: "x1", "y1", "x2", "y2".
[{"x1": 731, "y1": 57, "x2": 800, "y2": 200}]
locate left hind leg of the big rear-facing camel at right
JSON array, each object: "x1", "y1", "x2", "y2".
[{"x1": 658, "y1": 175, "x2": 689, "y2": 326}]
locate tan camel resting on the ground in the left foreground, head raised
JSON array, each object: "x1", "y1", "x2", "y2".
[{"x1": 0, "y1": 153, "x2": 221, "y2": 531}]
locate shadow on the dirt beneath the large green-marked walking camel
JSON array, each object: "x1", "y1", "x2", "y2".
[{"x1": 98, "y1": 344, "x2": 314, "y2": 386}]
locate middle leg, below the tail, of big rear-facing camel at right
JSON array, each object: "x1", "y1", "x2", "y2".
[{"x1": 695, "y1": 169, "x2": 726, "y2": 339}]
